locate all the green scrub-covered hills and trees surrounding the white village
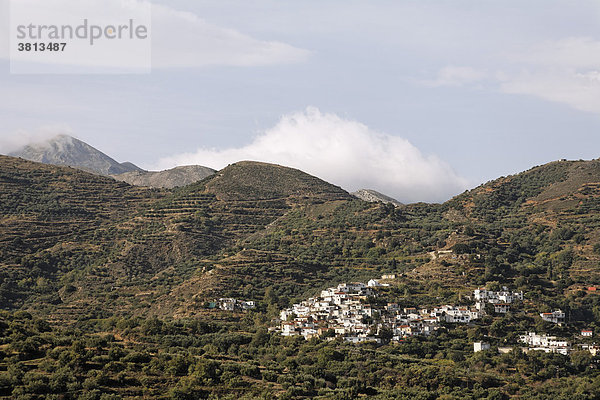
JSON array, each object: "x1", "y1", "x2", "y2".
[{"x1": 0, "y1": 157, "x2": 600, "y2": 399}]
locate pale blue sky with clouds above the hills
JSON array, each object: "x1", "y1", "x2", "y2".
[{"x1": 0, "y1": 0, "x2": 600, "y2": 202}]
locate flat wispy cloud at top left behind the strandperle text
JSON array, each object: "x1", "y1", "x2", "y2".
[{"x1": 0, "y1": 0, "x2": 310, "y2": 73}]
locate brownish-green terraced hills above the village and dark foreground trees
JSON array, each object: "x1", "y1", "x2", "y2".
[{"x1": 5, "y1": 157, "x2": 600, "y2": 321}]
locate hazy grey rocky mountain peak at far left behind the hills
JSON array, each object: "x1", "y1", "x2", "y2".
[{"x1": 9, "y1": 134, "x2": 141, "y2": 175}]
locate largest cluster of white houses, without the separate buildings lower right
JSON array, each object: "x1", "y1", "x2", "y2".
[{"x1": 279, "y1": 279, "x2": 523, "y2": 342}]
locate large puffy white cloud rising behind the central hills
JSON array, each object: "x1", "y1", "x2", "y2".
[{"x1": 159, "y1": 107, "x2": 467, "y2": 202}]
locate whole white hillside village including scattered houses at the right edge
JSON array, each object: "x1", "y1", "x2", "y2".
[{"x1": 271, "y1": 275, "x2": 600, "y2": 356}]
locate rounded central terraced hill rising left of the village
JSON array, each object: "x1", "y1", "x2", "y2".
[{"x1": 79, "y1": 162, "x2": 351, "y2": 315}]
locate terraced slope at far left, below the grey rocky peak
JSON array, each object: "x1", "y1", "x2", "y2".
[{"x1": 0, "y1": 156, "x2": 164, "y2": 307}]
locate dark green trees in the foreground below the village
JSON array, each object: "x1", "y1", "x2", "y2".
[{"x1": 0, "y1": 294, "x2": 600, "y2": 399}]
